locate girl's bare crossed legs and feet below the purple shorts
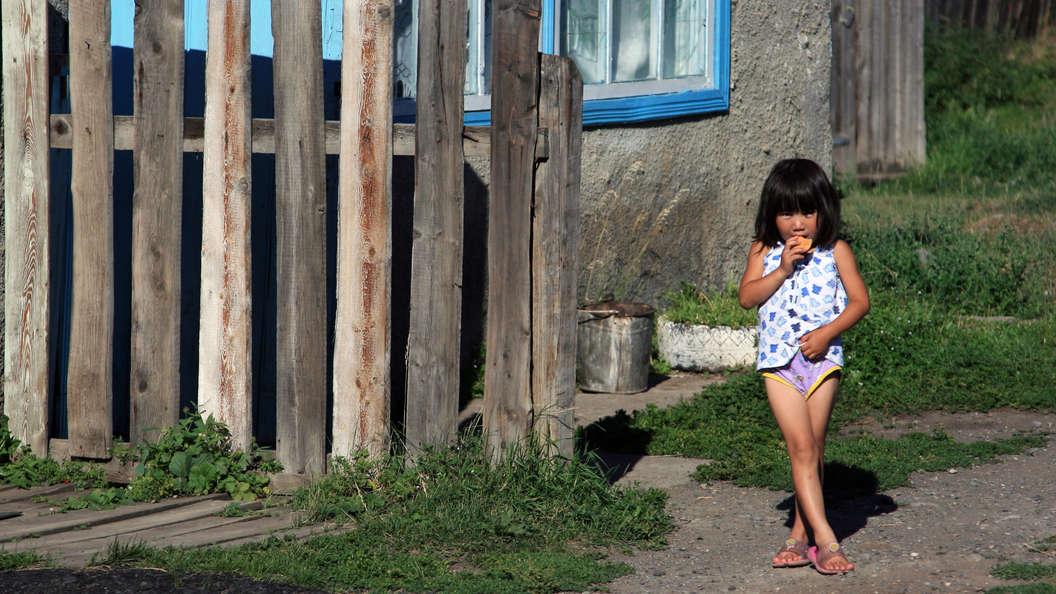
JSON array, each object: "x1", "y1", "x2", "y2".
[{"x1": 766, "y1": 374, "x2": 854, "y2": 571}]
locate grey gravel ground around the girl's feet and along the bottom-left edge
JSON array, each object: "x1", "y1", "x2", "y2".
[{"x1": 0, "y1": 409, "x2": 1056, "y2": 594}]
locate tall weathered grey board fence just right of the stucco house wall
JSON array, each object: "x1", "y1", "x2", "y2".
[{"x1": 830, "y1": 0, "x2": 926, "y2": 179}]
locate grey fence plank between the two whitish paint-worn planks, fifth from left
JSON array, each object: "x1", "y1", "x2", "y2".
[{"x1": 271, "y1": 0, "x2": 326, "y2": 474}]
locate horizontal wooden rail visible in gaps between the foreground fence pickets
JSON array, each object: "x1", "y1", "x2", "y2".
[{"x1": 51, "y1": 113, "x2": 549, "y2": 159}]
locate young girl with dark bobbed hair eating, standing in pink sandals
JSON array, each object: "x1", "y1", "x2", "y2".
[{"x1": 739, "y1": 159, "x2": 869, "y2": 574}]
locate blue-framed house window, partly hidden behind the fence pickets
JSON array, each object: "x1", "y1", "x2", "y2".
[{"x1": 395, "y1": 0, "x2": 730, "y2": 125}]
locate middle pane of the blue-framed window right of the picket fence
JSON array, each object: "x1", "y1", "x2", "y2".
[{"x1": 612, "y1": 0, "x2": 656, "y2": 82}]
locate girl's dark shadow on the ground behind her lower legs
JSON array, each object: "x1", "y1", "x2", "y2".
[{"x1": 777, "y1": 462, "x2": 899, "y2": 540}]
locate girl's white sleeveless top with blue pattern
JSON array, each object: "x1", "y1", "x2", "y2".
[{"x1": 755, "y1": 244, "x2": 848, "y2": 369}]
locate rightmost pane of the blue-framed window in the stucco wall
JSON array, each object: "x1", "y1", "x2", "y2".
[{"x1": 663, "y1": 0, "x2": 708, "y2": 78}]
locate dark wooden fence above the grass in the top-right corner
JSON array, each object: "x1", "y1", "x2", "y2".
[{"x1": 924, "y1": 0, "x2": 1056, "y2": 39}]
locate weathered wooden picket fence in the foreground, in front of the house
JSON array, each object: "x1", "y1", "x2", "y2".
[{"x1": 2, "y1": 0, "x2": 582, "y2": 474}]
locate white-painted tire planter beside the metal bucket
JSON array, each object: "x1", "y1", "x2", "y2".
[{"x1": 657, "y1": 319, "x2": 757, "y2": 371}]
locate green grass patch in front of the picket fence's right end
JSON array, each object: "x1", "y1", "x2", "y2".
[{"x1": 84, "y1": 429, "x2": 672, "y2": 593}]
